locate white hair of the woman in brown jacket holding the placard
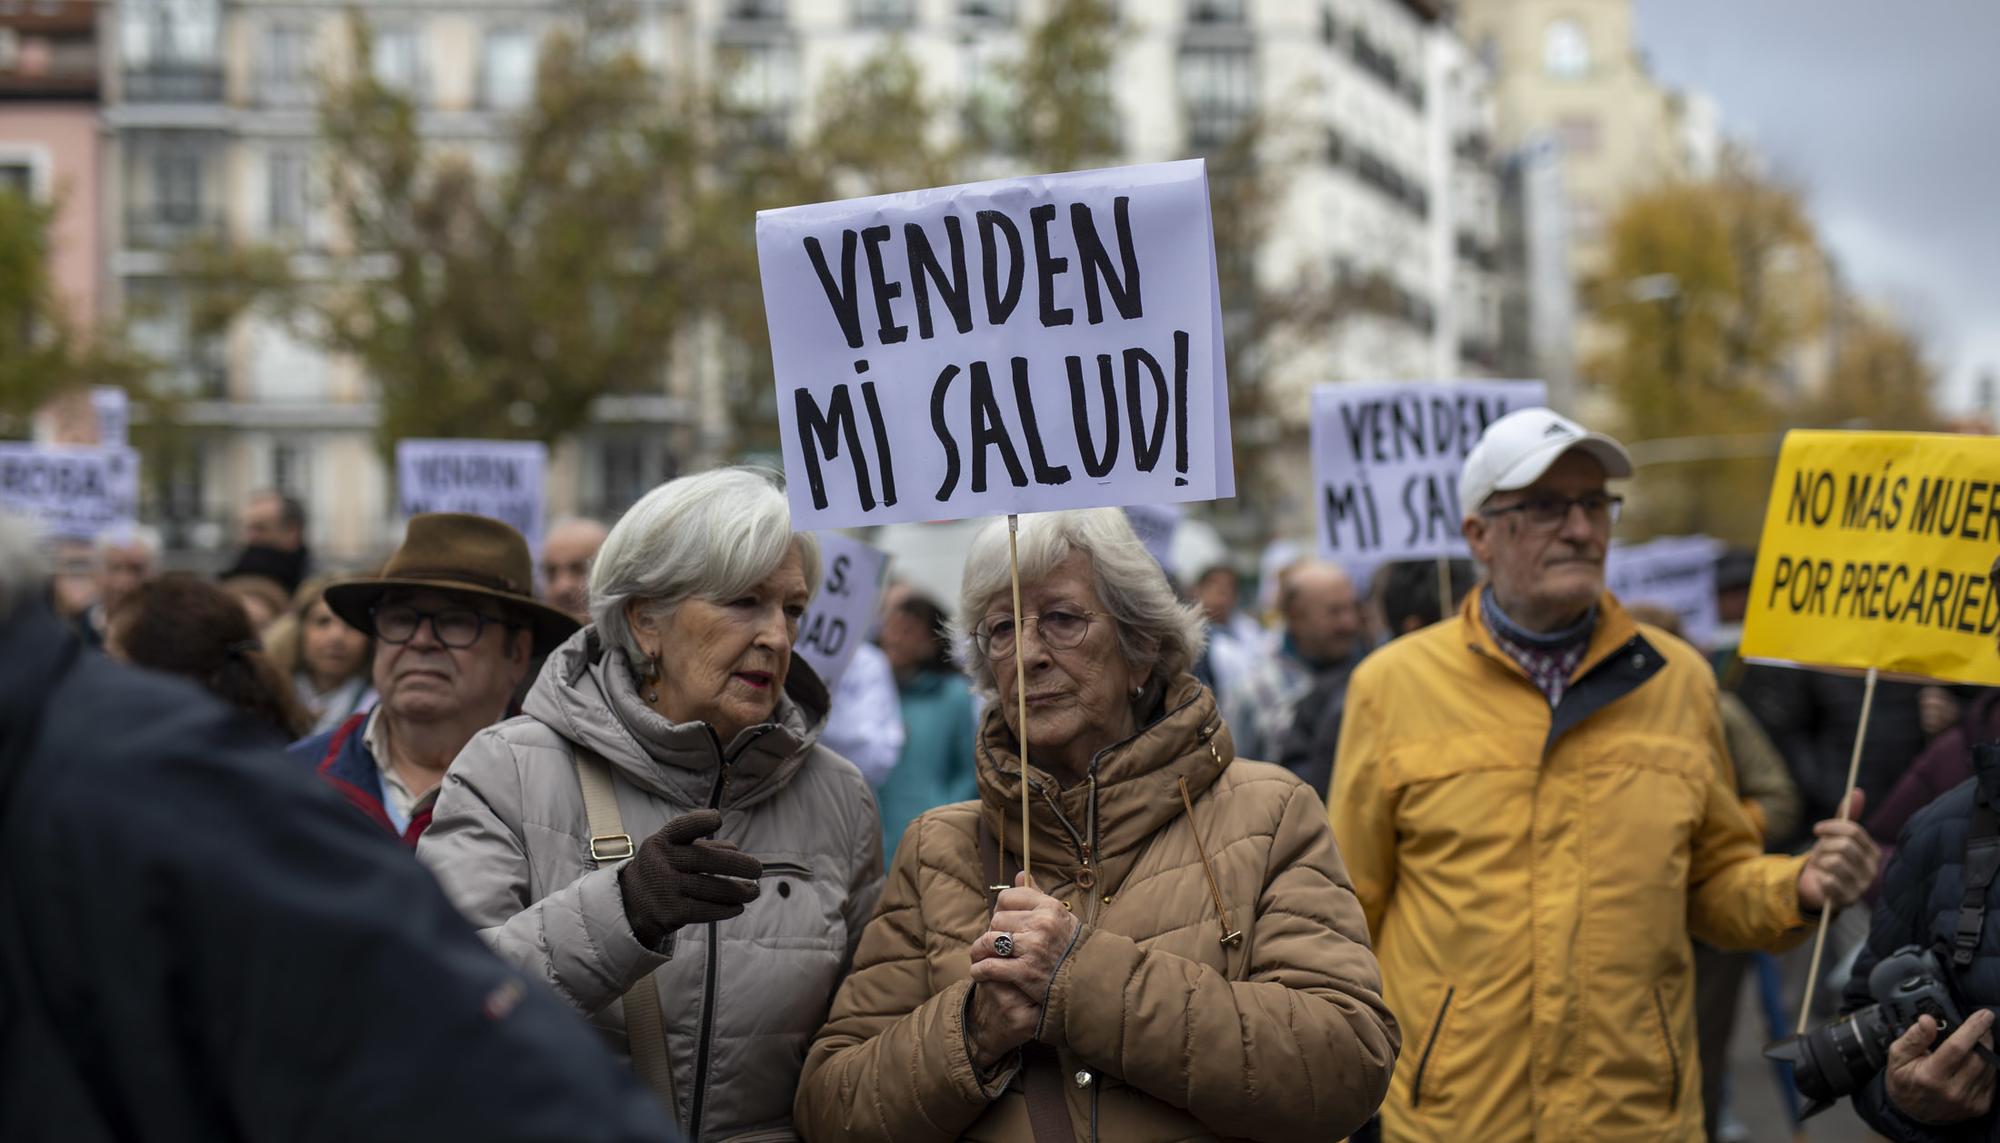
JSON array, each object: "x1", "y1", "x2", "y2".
[{"x1": 952, "y1": 508, "x2": 1208, "y2": 699}]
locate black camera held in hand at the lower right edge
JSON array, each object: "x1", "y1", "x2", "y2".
[{"x1": 1764, "y1": 945, "x2": 2000, "y2": 1119}]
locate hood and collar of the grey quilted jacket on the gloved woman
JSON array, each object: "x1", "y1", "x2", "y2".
[{"x1": 522, "y1": 625, "x2": 832, "y2": 809}]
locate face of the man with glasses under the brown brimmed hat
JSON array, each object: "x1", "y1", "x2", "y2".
[{"x1": 372, "y1": 589, "x2": 530, "y2": 721}]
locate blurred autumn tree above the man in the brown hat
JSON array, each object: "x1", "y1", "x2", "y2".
[{"x1": 184, "y1": 18, "x2": 704, "y2": 452}]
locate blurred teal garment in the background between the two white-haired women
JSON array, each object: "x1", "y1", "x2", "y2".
[{"x1": 876, "y1": 671, "x2": 978, "y2": 861}]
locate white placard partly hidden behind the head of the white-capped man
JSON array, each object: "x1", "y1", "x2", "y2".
[{"x1": 1312, "y1": 380, "x2": 1548, "y2": 570}]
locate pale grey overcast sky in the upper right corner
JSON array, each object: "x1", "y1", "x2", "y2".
[{"x1": 1638, "y1": 0, "x2": 2000, "y2": 410}]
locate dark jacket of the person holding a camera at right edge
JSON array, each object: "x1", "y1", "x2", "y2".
[{"x1": 1842, "y1": 735, "x2": 2000, "y2": 1143}]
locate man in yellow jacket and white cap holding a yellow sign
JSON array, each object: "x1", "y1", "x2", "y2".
[{"x1": 1330, "y1": 410, "x2": 1876, "y2": 1143}]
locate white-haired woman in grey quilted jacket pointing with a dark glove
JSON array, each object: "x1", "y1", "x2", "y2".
[{"x1": 418, "y1": 468, "x2": 882, "y2": 1139}]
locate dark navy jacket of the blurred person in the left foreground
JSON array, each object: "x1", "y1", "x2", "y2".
[{"x1": 0, "y1": 607, "x2": 672, "y2": 1143}]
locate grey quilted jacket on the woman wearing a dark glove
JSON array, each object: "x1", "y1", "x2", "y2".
[{"x1": 418, "y1": 627, "x2": 882, "y2": 1141}]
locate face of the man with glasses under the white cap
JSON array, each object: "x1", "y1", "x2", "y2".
[{"x1": 1464, "y1": 452, "x2": 1620, "y2": 631}]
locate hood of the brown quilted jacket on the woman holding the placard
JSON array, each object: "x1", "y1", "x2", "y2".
[{"x1": 978, "y1": 673, "x2": 1236, "y2": 869}]
